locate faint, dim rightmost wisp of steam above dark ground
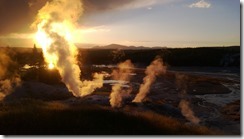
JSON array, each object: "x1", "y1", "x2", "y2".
[{"x1": 176, "y1": 74, "x2": 200, "y2": 124}]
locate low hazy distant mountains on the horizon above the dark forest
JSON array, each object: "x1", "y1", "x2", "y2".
[{"x1": 92, "y1": 44, "x2": 163, "y2": 50}]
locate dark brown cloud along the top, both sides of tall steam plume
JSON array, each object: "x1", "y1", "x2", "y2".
[{"x1": 0, "y1": 0, "x2": 136, "y2": 35}]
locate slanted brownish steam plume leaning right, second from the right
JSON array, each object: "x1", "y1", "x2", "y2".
[{"x1": 132, "y1": 58, "x2": 166, "y2": 103}]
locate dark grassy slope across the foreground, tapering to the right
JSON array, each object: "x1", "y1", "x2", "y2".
[{"x1": 0, "y1": 100, "x2": 221, "y2": 135}]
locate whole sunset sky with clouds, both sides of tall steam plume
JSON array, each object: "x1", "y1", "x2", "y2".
[{"x1": 0, "y1": 0, "x2": 241, "y2": 47}]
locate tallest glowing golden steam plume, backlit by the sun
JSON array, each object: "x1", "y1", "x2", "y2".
[{"x1": 33, "y1": 0, "x2": 103, "y2": 97}]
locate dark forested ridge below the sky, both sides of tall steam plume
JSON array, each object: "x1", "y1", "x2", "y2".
[{"x1": 1, "y1": 45, "x2": 240, "y2": 67}]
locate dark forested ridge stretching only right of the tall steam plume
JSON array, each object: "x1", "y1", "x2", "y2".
[{"x1": 79, "y1": 44, "x2": 241, "y2": 67}]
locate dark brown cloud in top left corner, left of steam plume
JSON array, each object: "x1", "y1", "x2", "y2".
[{"x1": 0, "y1": 0, "x2": 48, "y2": 34}]
